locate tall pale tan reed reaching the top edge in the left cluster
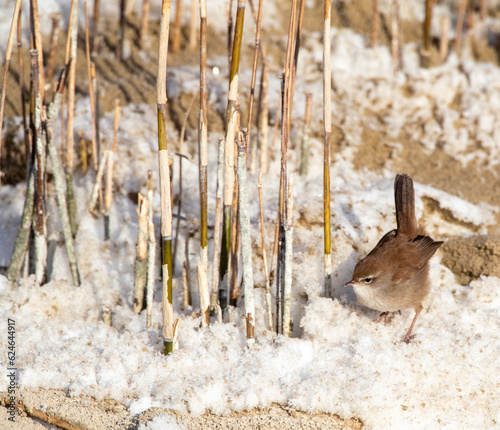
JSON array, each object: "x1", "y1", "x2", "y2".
[{"x1": 65, "y1": 0, "x2": 78, "y2": 237}]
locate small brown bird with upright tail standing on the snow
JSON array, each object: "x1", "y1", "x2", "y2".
[{"x1": 345, "y1": 174, "x2": 443, "y2": 343}]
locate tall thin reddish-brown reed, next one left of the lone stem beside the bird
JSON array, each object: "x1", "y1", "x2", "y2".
[{"x1": 276, "y1": 0, "x2": 297, "y2": 333}]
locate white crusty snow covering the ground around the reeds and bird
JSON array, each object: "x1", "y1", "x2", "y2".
[{"x1": 0, "y1": 0, "x2": 500, "y2": 429}]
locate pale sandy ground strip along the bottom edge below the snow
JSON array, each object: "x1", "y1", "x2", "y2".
[{"x1": 0, "y1": 390, "x2": 363, "y2": 430}]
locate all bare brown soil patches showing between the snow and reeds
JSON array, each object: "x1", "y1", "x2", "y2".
[{"x1": 0, "y1": 0, "x2": 500, "y2": 429}]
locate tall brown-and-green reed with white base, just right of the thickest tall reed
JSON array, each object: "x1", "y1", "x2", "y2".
[{"x1": 198, "y1": 0, "x2": 210, "y2": 325}]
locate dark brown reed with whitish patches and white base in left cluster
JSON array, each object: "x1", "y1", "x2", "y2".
[{"x1": 30, "y1": 49, "x2": 47, "y2": 285}]
